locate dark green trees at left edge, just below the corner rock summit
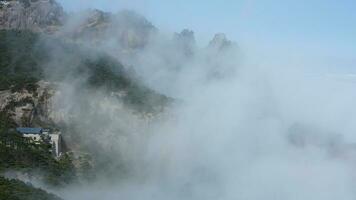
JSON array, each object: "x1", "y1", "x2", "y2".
[{"x1": 0, "y1": 31, "x2": 45, "y2": 91}]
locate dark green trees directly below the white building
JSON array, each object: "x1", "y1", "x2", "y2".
[{"x1": 0, "y1": 128, "x2": 75, "y2": 185}]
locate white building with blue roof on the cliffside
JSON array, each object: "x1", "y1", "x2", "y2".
[{"x1": 16, "y1": 127, "x2": 62, "y2": 157}]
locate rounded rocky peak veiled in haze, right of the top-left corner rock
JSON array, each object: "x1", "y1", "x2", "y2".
[{"x1": 70, "y1": 10, "x2": 156, "y2": 50}]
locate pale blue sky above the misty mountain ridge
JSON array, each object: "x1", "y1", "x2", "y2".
[{"x1": 59, "y1": 0, "x2": 356, "y2": 71}]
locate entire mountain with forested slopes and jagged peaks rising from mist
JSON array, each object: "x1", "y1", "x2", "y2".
[{"x1": 0, "y1": 0, "x2": 233, "y2": 199}]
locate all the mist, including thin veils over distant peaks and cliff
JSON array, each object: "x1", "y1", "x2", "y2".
[{"x1": 19, "y1": 3, "x2": 356, "y2": 200}]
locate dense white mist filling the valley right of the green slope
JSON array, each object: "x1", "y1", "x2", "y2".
[{"x1": 57, "y1": 38, "x2": 356, "y2": 199}]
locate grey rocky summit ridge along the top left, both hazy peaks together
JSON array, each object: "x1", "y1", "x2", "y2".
[{"x1": 0, "y1": 0, "x2": 156, "y2": 50}]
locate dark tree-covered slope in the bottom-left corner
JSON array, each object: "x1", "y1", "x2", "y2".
[{"x1": 0, "y1": 176, "x2": 60, "y2": 200}]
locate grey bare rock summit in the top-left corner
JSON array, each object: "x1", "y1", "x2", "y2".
[{"x1": 0, "y1": 0, "x2": 65, "y2": 33}]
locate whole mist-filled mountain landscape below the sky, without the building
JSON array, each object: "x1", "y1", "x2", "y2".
[{"x1": 0, "y1": 0, "x2": 356, "y2": 200}]
